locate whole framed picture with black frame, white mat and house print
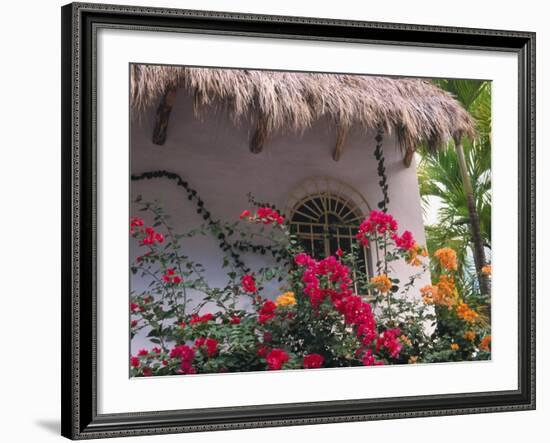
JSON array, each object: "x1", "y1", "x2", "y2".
[{"x1": 62, "y1": 3, "x2": 535, "y2": 439}]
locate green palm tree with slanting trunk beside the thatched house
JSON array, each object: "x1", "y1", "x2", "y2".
[{"x1": 419, "y1": 80, "x2": 491, "y2": 294}]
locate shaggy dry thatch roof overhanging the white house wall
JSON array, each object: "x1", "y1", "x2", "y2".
[{"x1": 130, "y1": 64, "x2": 475, "y2": 151}]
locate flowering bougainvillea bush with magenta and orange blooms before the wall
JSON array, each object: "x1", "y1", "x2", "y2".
[{"x1": 130, "y1": 202, "x2": 491, "y2": 376}]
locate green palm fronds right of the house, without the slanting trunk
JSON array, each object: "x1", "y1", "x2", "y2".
[{"x1": 418, "y1": 80, "x2": 491, "y2": 294}]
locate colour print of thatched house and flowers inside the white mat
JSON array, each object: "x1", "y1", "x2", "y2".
[{"x1": 128, "y1": 64, "x2": 491, "y2": 377}]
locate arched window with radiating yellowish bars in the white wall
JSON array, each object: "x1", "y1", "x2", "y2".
[{"x1": 290, "y1": 189, "x2": 372, "y2": 276}]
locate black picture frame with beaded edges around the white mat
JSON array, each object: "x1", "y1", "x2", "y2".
[{"x1": 61, "y1": 3, "x2": 535, "y2": 439}]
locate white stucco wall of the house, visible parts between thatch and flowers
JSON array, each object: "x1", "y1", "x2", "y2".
[{"x1": 131, "y1": 92, "x2": 430, "y2": 348}]
